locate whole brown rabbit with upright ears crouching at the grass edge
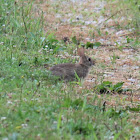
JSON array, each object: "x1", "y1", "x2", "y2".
[{"x1": 50, "y1": 48, "x2": 95, "y2": 81}]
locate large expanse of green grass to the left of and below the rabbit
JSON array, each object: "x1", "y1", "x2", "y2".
[{"x1": 0, "y1": 0, "x2": 140, "y2": 140}]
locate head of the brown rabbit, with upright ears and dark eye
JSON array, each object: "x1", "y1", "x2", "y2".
[{"x1": 78, "y1": 48, "x2": 95, "y2": 67}]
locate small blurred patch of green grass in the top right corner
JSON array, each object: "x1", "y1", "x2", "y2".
[{"x1": 106, "y1": 0, "x2": 140, "y2": 31}]
